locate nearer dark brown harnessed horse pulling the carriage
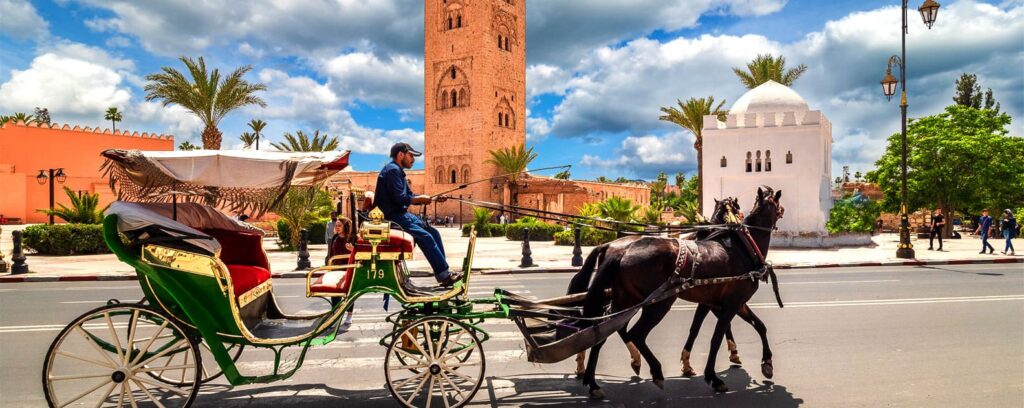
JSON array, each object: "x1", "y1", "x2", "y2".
[{"x1": 570, "y1": 189, "x2": 784, "y2": 398}]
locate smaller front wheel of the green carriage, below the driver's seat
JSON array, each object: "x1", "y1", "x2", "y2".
[{"x1": 384, "y1": 317, "x2": 485, "y2": 407}]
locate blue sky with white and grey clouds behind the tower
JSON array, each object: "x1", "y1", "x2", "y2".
[{"x1": 0, "y1": 0, "x2": 1024, "y2": 178}]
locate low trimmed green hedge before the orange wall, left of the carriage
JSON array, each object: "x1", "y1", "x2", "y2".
[{"x1": 23, "y1": 223, "x2": 111, "y2": 255}]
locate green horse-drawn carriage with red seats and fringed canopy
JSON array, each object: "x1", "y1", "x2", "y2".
[{"x1": 42, "y1": 151, "x2": 786, "y2": 407}]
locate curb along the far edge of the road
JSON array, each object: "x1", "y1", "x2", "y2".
[{"x1": 0, "y1": 257, "x2": 1024, "y2": 283}]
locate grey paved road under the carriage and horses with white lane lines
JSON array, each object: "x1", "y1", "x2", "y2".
[{"x1": 0, "y1": 264, "x2": 1024, "y2": 407}]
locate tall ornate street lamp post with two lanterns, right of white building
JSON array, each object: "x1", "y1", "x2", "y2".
[{"x1": 882, "y1": 0, "x2": 939, "y2": 258}]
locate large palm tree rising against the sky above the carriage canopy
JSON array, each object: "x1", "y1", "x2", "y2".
[{"x1": 145, "y1": 56, "x2": 266, "y2": 150}]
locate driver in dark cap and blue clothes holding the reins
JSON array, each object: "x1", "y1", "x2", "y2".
[{"x1": 374, "y1": 142, "x2": 462, "y2": 286}]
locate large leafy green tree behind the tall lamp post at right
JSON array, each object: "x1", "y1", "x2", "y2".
[{"x1": 867, "y1": 105, "x2": 1024, "y2": 235}]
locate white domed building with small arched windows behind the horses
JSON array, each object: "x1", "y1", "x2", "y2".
[{"x1": 702, "y1": 81, "x2": 833, "y2": 246}]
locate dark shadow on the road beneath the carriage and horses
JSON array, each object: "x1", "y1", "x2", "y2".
[{"x1": 196, "y1": 367, "x2": 804, "y2": 407}]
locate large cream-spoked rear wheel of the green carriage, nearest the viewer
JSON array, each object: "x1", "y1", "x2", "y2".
[{"x1": 43, "y1": 304, "x2": 202, "y2": 407}]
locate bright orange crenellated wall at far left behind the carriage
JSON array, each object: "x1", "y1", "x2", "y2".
[{"x1": 0, "y1": 122, "x2": 174, "y2": 222}]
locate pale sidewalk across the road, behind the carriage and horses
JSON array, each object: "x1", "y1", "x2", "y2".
[{"x1": 0, "y1": 226, "x2": 1024, "y2": 283}]
